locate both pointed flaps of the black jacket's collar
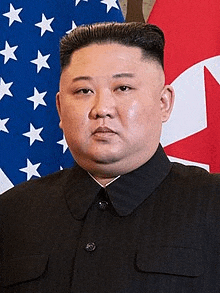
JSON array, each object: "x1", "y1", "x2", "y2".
[{"x1": 64, "y1": 145, "x2": 171, "y2": 220}]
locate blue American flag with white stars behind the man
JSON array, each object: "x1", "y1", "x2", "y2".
[{"x1": 0, "y1": 0, "x2": 124, "y2": 193}]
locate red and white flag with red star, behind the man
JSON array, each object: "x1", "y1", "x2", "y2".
[{"x1": 148, "y1": 0, "x2": 220, "y2": 172}]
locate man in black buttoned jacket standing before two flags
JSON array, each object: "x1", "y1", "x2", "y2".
[{"x1": 0, "y1": 23, "x2": 220, "y2": 293}]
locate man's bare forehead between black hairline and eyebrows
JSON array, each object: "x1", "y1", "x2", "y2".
[{"x1": 63, "y1": 43, "x2": 162, "y2": 81}]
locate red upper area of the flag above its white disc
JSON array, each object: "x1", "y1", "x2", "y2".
[{"x1": 148, "y1": 0, "x2": 220, "y2": 83}]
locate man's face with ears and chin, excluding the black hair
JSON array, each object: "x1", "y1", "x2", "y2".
[{"x1": 57, "y1": 43, "x2": 173, "y2": 177}]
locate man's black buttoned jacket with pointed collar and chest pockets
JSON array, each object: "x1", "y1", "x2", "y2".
[{"x1": 0, "y1": 148, "x2": 220, "y2": 293}]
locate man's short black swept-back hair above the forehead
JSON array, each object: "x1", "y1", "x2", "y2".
[{"x1": 60, "y1": 22, "x2": 165, "y2": 71}]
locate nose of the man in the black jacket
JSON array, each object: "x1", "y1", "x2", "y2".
[{"x1": 90, "y1": 90, "x2": 116, "y2": 119}]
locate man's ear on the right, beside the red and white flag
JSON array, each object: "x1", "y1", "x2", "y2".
[{"x1": 160, "y1": 85, "x2": 175, "y2": 122}]
